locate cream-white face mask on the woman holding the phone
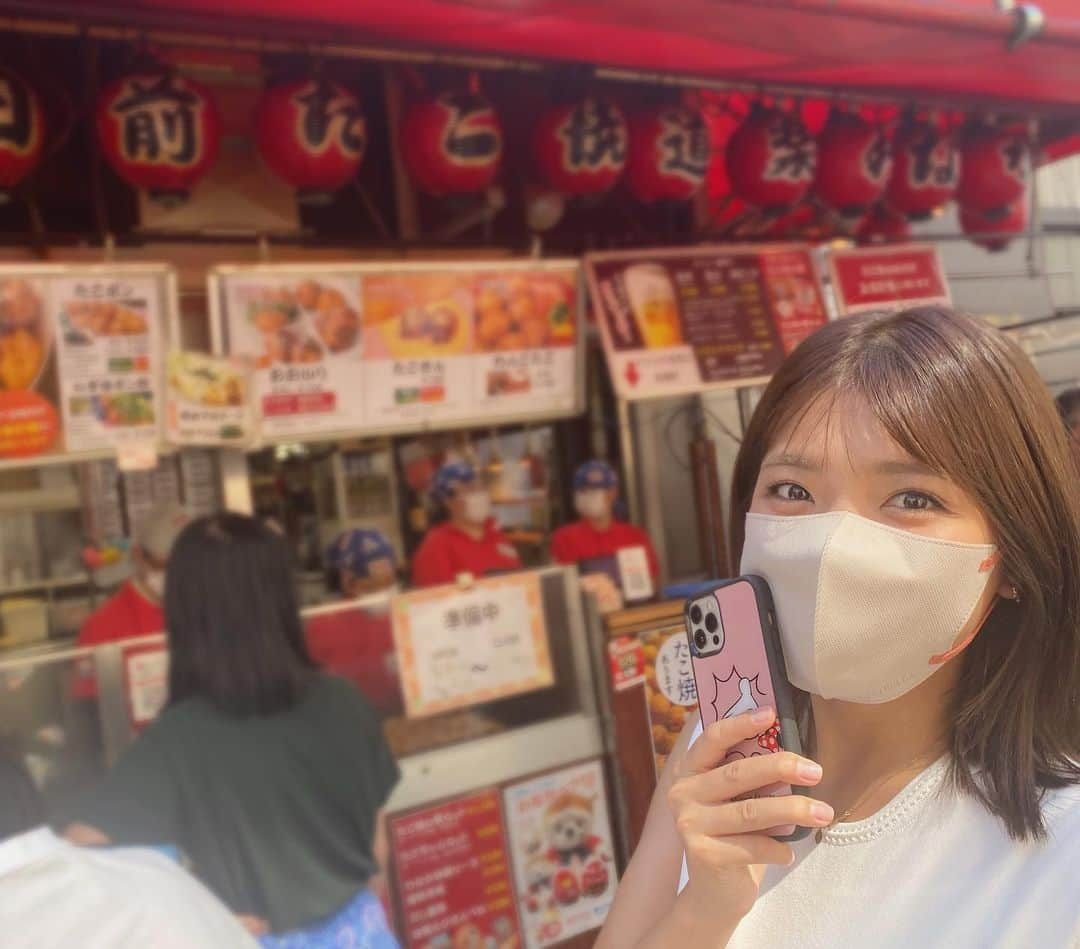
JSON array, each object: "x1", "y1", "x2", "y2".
[{"x1": 741, "y1": 511, "x2": 997, "y2": 704}]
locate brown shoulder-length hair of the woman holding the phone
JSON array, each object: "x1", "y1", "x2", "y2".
[{"x1": 731, "y1": 307, "x2": 1080, "y2": 839}]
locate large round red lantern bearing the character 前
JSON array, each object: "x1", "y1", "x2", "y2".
[{"x1": 97, "y1": 72, "x2": 221, "y2": 203}]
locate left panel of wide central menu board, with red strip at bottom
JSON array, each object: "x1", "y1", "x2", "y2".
[{"x1": 222, "y1": 268, "x2": 365, "y2": 437}]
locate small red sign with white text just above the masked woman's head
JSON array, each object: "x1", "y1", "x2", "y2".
[{"x1": 828, "y1": 245, "x2": 950, "y2": 316}]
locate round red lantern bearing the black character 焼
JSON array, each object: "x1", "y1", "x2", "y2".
[{"x1": 532, "y1": 98, "x2": 629, "y2": 196}]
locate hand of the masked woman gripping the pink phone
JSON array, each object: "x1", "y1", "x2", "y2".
[{"x1": 667, "y1": 708, "x2": 833, "y2": 919}]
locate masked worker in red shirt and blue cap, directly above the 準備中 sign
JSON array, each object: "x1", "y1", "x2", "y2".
[{"x1": 413, "y1": 462, "x2": 522, "y2": 586}]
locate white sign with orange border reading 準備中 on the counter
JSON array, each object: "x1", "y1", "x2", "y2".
[{"x1": 393, "y1": 574, "x2": 555, "y2": 717}]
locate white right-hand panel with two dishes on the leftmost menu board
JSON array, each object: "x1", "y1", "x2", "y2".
[{"x1": 49, "y1": 272, "x2": 163, "y2": 451}]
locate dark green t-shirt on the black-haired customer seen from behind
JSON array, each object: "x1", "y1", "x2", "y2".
[{"x1": 78, "y1": 676, "x2": 399, "y2": 933}]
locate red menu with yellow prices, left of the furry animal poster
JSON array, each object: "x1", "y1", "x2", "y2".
[{"x1": 390, "y1": 789, "x2": 521, "y2": 949}]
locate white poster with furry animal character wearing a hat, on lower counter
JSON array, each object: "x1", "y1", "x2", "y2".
[{"x1": 503, "y1": 761, "x2": 617, "y2": 949}]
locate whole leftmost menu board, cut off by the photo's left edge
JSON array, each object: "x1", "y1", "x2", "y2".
[{"x1": 0, "y1": 265, "x2": 168, "y2": 458}]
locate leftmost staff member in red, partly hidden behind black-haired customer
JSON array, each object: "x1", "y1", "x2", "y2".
[{"x1": 73, "y1": 504, "x2": 191, "y2": 699}]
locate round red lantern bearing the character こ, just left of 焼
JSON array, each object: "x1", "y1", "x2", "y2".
[{"x1": 401, "y1": 93, "x2": 502, "y2": 196}]
